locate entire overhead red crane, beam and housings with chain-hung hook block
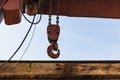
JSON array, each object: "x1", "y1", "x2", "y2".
[{"x1": 0, "y1": 0, "x2": 120, "y2": 58}]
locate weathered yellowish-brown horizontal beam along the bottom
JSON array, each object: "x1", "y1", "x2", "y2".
[{"x1": 0, "y1": 61, "x2": 120, "y2": 80}]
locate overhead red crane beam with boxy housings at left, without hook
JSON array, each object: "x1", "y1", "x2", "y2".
[{"x1": 0, "y1": 0, "x2": 120, "y2": 25}]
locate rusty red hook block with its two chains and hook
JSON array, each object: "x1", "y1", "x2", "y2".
[{"x1": 47, "y1": 0, "x2": 60, "y2": 58}]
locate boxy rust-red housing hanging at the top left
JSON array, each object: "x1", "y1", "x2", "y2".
[{"x1": 3, "y1": 0, "x2": 21, "y2": 25}]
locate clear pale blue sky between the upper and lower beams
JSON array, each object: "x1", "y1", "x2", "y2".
[{"x1": 0, "y1": 15, "x2": 120, "y2": 60}]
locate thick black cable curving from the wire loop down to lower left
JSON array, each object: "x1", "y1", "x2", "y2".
[{"x1": 0, "y1": 14, "x2": 36, "y2": 67}]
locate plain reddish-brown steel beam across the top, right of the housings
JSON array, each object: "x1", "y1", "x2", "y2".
[{"x1": 43, "y1": 0, "x2": 120, "y2": 18}]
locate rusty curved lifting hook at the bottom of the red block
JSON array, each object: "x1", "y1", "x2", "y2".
[{"x1": 47, "y1": 44, "x2": 60, "y2": 59}]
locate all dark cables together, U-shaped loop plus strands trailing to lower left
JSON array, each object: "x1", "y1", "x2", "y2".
[{"x1": 0, "y1": 0, "x2": 43, "y2": 70}]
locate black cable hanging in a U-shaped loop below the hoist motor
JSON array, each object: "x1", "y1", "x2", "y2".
[{"x1": 19, "y1": 0, "x2": 43, "y2": 24}]
